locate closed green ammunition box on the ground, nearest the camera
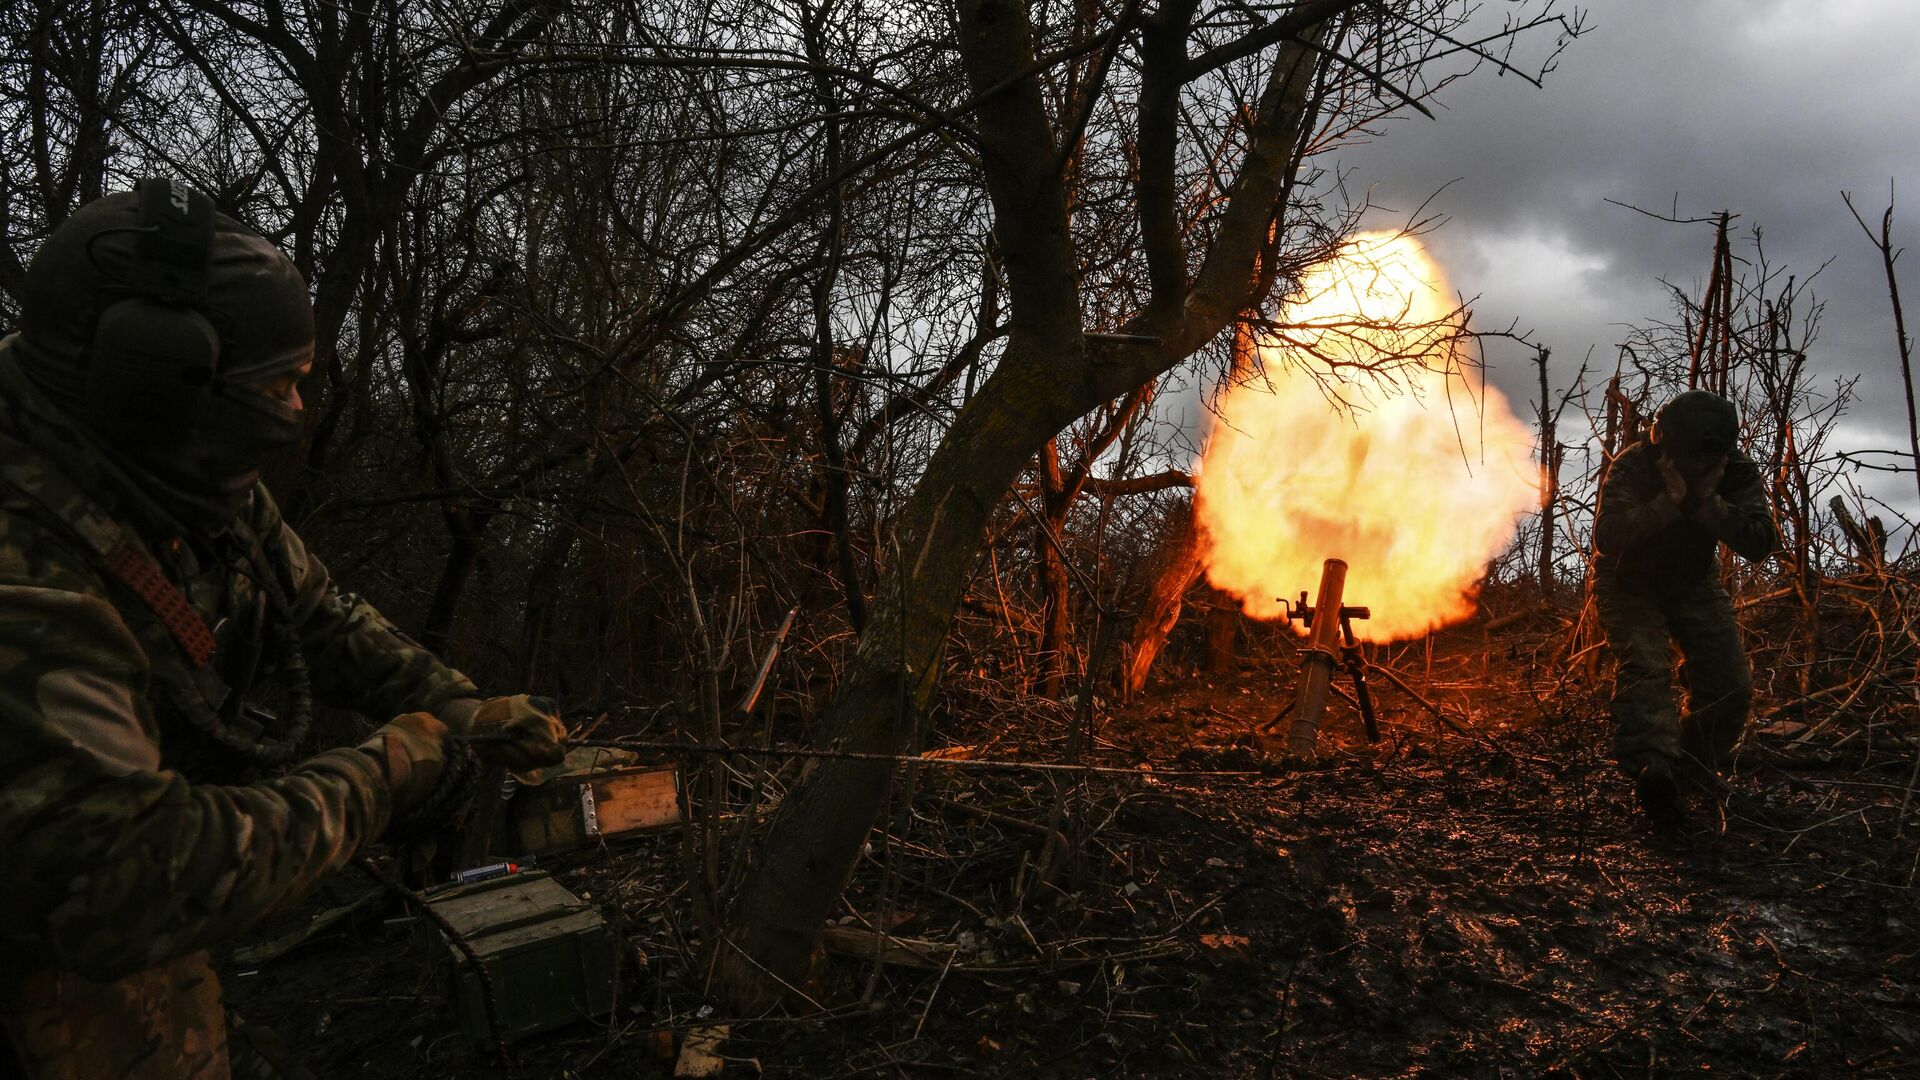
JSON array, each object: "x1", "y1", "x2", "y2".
[{"x1": 420, "y1": 871, "x2": 614, "y2": 1045}]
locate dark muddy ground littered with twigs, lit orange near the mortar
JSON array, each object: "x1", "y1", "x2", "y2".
[{"x1": 225, "y1": 618, "x2": 1920, "y2": 1078}]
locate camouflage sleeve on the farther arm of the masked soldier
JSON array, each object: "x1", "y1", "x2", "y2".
[{"x1": 255, "y1": 488, "x2": 480, "y2": 726}]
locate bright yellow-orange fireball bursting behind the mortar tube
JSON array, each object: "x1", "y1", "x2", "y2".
[{"x1": 1194, "y1": 233, "x2": 1540, "y2": 642}]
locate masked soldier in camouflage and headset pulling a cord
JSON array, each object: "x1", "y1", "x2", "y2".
[{"x1": 0, "y1": 181, "x2": 564, "y2": 1080}]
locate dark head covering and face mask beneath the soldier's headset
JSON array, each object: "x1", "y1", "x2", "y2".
[{"x1": 17, "y1": 192, "x2": 313, "y2": 536}]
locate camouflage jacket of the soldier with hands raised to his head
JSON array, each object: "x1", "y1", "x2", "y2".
[{"x1": 1594, "y1": 442, "x2": 1774, "y2": 592}]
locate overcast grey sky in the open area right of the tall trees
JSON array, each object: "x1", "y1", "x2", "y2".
[{"x1": 1338, "y1": 0, "x2": 1920, "y2": 507}]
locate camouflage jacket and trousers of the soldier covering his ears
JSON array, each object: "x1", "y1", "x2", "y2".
[{"x1": 1594, "y1": 442, "x2": 1774, "y2": 776}]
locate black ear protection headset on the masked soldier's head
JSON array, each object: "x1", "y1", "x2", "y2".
[{"x1": 86, "y1": 179, "x2": 221, "y2": 442}]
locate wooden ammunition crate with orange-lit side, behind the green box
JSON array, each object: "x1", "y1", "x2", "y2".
[{"x1": 507, "y1": 765, "x2": 680, "y2": 855}]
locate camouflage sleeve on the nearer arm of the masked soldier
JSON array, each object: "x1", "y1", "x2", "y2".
[{"x1": 0, "y1": 519, "x2": 392, "y2": 980}]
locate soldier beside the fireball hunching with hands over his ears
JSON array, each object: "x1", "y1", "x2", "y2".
[{"x1": 1594, "y1": 390, "x2": 1774, "y2": 828}]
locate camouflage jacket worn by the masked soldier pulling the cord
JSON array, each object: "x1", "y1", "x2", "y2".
[{"x1": 0, "y1": 332, "x2": 478, "y2": 1078}]
